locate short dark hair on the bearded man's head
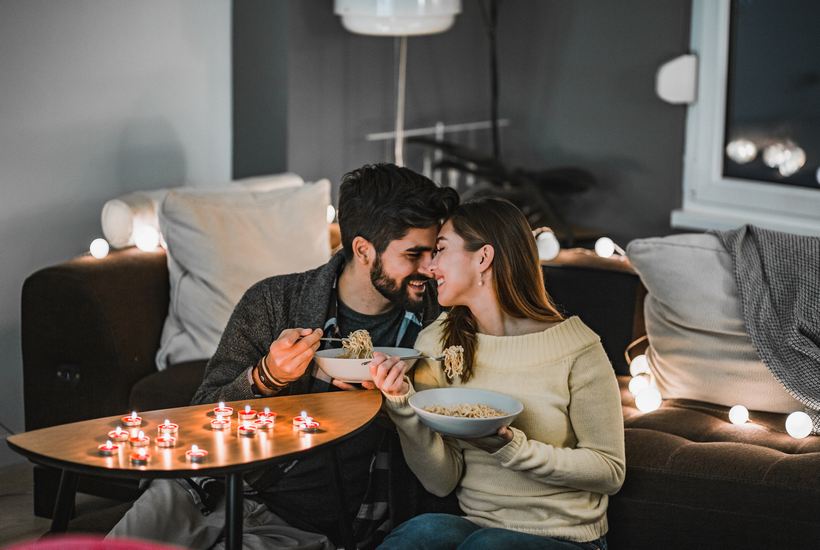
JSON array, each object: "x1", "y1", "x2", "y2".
[{"x1": 339, "y1": 164, "x2": 459, "y2": 261}]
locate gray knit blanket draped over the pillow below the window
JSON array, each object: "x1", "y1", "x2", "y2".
[{"x1": 715, "y1": 225, "x2": 820, "y2": 434}]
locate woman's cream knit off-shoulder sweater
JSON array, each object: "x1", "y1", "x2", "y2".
[{"x1": 385, "y1": 314, "x2": 625, "y2": 542}]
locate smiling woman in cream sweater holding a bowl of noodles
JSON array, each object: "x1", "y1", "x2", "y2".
[{"x1": 364, "y1": 199, "x2": 624, "y2": 549}]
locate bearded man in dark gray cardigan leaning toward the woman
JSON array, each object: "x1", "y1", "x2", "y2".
[{"x1": 109, "y1": 164, "x2": 458, "y2": 548}]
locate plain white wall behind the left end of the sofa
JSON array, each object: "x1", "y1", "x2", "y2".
[{"x1": 0, "y1": 0, "x2": 231, "y2": 465}]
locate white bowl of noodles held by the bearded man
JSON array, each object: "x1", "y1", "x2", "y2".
[{"x1": 314, "y1": 330, "x2": 419, "y2": 383}]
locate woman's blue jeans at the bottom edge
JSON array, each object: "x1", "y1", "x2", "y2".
[{"x1": 379, "y1": 514, "x2": 606, "y2": 550}]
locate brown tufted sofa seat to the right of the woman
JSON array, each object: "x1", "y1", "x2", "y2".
[{"x1": 607, "y1": 376, "x2": 820, "y2": 548}]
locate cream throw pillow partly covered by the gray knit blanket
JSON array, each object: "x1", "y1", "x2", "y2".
[{"x1": 627, "y1": 233, "x2": 802, "y2": 413}]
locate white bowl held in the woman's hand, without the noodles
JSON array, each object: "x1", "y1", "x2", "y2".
[{"x1": 409, "y1": 388, "x2": 524, "y2": 439}]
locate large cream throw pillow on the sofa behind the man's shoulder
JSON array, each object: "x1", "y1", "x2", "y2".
[{"x1": 157, "y1": 180, "x2": 330, "y2": 370}]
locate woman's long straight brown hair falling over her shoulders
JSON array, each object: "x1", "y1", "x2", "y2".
[{"x1": 442, "y1": 198, "x2": 564, "y2": 382}]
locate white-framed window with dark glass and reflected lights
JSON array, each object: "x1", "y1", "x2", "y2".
[{"x1": 672, "y1": 0, "x2": 820, "y2": 235}]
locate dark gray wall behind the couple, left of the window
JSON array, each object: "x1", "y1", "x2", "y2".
[{"x1": 235, "y1": 0, "x2": 690, "y2": 244}]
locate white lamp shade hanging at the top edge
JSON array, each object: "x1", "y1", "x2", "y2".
[{"x1": 334, "y1": 0, "x2": 461, "y2": 36}]
